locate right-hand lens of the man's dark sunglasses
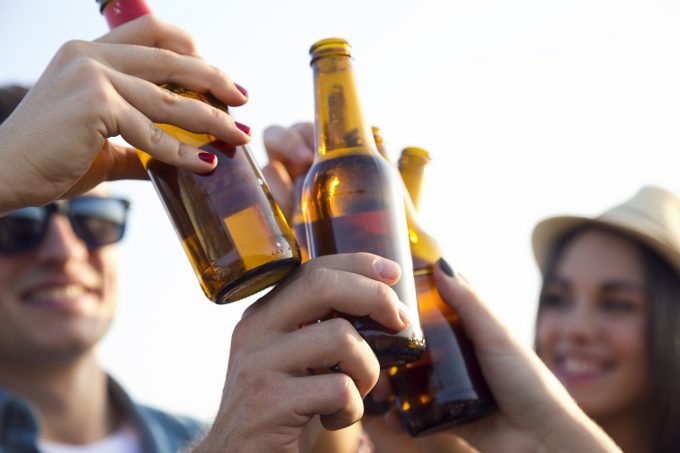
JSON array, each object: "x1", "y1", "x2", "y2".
[{"x1": 69, "y1": 197, "x2": 128, "y2": 248}]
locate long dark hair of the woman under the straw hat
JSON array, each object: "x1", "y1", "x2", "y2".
[{"x1": 537, "y1": 224, "x2": 680, "y2": 452}]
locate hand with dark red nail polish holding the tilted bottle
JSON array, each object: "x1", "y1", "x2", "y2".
[{"x1": 0, "y1": 16, "x2": 249, "y2": 212}]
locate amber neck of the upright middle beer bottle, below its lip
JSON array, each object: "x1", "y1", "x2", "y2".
[{"x1": 312, "y1": 55, "x2": 378, "y2": 156}]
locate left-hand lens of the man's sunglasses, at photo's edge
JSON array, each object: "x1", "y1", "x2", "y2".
[{"x1": 0, "y1": 208, "x2": 47, "y2": 253}]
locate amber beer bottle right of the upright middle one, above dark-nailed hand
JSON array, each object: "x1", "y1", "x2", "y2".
[{"x1": 389, "y1": 148, "x2": 496, "y2": 436}]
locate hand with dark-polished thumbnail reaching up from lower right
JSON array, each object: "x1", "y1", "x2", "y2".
[{"x1": 378, "y1": 261, "x2": 620, "y2": 452}]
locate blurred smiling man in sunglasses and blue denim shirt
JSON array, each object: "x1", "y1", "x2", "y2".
[{"x1": 0, "y1": 87, "x2": 201, "y2": 453}]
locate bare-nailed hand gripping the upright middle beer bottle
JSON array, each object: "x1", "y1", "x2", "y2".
[{"x1": 197, "y1": 253, "x2": 408, "y2": 452}]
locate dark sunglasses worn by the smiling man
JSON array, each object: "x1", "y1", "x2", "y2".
[{"x1": 0, "y1": 196, "x2": 130, "y2": 254}]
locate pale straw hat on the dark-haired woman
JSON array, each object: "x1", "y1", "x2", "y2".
[{"x1": 532, "y1": 187, "x2": 680, "y2": 273}]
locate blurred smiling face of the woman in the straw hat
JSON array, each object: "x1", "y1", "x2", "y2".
[{"x1": 537, "y1": 230, "x2": 648, "y2": 419}]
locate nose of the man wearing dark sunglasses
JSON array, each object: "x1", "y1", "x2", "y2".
[{"x1": 37, "y1": 214, "x2": 88, "y2": 264}]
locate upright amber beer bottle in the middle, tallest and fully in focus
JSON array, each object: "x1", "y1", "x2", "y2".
[{"x1": 302, "y1": 38, "x2": 425, "y2": 367}]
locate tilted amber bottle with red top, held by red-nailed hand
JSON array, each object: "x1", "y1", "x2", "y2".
[{"x1": 97, "y1": 0, "x2": 300, "y2": 304}]
